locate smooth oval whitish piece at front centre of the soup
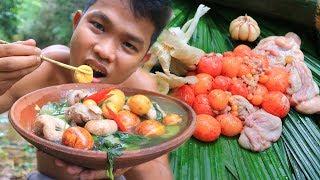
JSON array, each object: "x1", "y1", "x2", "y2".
[{"x1": 84, "y1": 119, "x2": 118, "y2": 136}]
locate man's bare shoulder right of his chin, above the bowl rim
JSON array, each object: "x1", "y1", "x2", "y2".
[{"x1": 121, "y1": 68, "x2": 157, "y2": 91}]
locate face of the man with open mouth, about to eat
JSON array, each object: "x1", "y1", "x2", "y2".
[{"x1": 70, "y1": 0, "x2": 155, "y2": 84}]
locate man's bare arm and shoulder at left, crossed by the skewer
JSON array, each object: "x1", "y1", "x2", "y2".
[{"x1": 0, "y1": 45, "x2": 69, "y2": 113}]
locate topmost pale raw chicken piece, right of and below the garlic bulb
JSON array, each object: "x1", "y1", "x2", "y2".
[{"x1": 254, "y1": 32, "x2": 304, "y2": 66}]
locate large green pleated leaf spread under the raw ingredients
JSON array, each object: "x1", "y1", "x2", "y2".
[{"x1": 170, "y1": 1, "x2": 320, "y2": 180}]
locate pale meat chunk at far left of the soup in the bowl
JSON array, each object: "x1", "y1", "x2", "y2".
[{"x1": 35, "y1": 114, "x2": 69, "y2": 142}]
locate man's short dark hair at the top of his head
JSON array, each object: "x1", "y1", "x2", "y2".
[{"x1": 84, "y1": 0, "x2": 171, "y2": 45}]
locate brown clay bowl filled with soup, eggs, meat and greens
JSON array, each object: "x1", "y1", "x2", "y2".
[{"x1": 9, "y1": 84, "x2": 195, "y2": 172}]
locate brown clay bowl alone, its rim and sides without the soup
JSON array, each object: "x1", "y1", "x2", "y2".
[{"x1": 9, "y1": 84, "x2": 195, "y2": 169}]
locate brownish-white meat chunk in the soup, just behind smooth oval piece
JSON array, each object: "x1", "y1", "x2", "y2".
[{"x1": 66, "y1": 103, "x2": 102, "y2": 125}]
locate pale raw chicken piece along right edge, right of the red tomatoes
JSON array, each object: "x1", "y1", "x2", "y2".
[{"x1": 289, "y1": 61, "x2": 319, "y2": 105}]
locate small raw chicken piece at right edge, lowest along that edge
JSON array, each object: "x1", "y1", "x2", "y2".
[{"x1": 295, "y1": 95, "x2": 320, "y2": 114}]
